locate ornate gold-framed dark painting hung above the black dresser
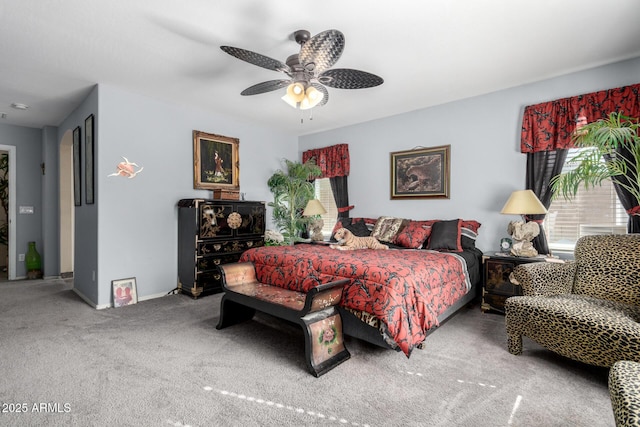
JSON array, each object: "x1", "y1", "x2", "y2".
[{"x1": 193, "y1": 130, "x2": 240, "y2": 190}]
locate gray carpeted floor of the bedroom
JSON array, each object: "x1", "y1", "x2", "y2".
[{"x1": 0, "y1": 280, "x2": 614, "y2": 427}]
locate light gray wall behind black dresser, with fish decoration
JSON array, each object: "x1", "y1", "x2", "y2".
[{"x1": 91, "y1": 85, "x2": 297, "y2": 306}]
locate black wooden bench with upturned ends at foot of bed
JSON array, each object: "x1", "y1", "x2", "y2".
[{"x1": 216, "y1": 262, "x2": 351, "y2": 377}]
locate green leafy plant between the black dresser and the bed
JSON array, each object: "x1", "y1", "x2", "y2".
[{"x1": 267, "y1": 159, "x2": 322, "y2": 244}]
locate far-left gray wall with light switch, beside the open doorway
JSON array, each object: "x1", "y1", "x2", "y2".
[{"x1": 0, "y1": 124, "x2": 43, "y2": 278}]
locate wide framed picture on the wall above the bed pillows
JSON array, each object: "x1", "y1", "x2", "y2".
[{"x1": 391, "y1": 145, "x2": 451, "y2": 199}]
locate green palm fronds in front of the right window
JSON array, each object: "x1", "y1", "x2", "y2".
[{"x1": 551, "y1": 109, "x2": 640, "y2": 205}]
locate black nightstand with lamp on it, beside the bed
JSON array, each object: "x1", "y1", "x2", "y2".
[{"x1": 480, "y1": 254, "x2": 545, "y2": 314}]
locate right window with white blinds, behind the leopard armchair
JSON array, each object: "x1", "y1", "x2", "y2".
[{"x1": 544, "y1": 148, "x2": 628, "y2": 251}]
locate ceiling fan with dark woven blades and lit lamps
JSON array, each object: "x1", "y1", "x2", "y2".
[{"x1": 220, "y1": 30, "x2": 384, "y2": 110}]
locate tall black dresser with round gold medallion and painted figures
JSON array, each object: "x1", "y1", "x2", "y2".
[{"x1": 178, "y1": 199, "x2": 265, "y2": 298}]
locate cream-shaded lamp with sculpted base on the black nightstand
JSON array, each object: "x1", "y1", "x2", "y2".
[{"x1": 500, "y1": 190, "x2": 547, "y2": 257}]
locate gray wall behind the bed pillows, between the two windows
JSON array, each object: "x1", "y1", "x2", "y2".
[{"x1": 299, "y1": 58, "x2": 640, "y2": 251}]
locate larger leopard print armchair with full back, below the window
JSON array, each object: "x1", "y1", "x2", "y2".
[{"x1": 505, "y1": 234, "x2": 640, "y2": 367}]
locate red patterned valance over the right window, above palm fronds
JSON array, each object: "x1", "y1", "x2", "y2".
[{"x1": 520, "y1": 84, "x2": 640, "y2": 153}]
